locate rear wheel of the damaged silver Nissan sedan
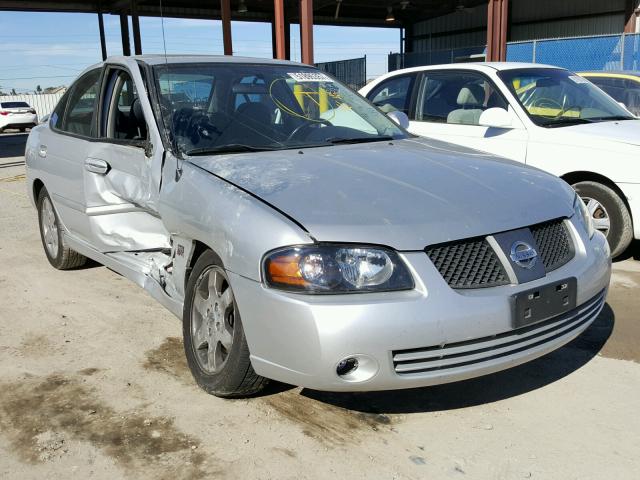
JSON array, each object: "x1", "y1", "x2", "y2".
[{"x1": 37, "y1": 187, "x2": 87, "y2": 270}]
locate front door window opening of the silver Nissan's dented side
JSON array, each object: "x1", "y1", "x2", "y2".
[{"x1": 106, "y1": 71, "x2": 147, "y2": 140}]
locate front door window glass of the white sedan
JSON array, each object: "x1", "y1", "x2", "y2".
[{"x1": 415, "y1": 72, "x2": 507, "y2": 125}]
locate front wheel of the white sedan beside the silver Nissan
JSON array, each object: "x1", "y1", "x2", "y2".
[{"x1": 572, "y1": 182, "x2": 633, "y2": 258}]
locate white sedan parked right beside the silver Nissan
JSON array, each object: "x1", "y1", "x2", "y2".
[{"x1": 360, "y1": 63, "x2": 640, "y2": 257}]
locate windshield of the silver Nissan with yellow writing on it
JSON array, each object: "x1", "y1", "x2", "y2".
[{"x1": 154, "y1": 63, "x2": 407, "y2": 155}]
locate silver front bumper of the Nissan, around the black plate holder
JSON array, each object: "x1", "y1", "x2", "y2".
[{"x1": 230, "y1": 218, "x2": 611, "y2": 391}]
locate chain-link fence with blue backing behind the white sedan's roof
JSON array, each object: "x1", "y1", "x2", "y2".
[{"x1": 389, "y1": 33, "x2": 640, "y2": 71}]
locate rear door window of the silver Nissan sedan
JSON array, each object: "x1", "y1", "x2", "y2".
[{"x1": 58, "y1": 69, "x2": 101, "y2": 137}]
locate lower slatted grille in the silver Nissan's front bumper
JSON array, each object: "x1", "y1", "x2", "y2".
[{"x1": 392, "y1": 290, "x2": 605, "y2": 376}]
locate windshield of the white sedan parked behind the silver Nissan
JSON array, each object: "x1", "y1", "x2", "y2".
[{"x1": 498, "y1": 68, "x2": 634, "y2": 128}]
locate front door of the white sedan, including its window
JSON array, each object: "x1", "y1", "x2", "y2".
[{"x1": 409, "y1": 70, "x2": 528, "y2": 162}]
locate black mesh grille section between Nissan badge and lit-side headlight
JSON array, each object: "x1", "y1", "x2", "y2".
[{"x1": 425, "y1": 238, "x2": 509, "y2": 288}]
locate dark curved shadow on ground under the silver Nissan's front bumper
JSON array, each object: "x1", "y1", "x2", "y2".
[{"x1": 301, "y1": 304, "x2": 615, "y2": 414}]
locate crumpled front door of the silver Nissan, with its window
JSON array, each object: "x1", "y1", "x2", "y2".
[{"x1": 83, "y1": 62, "x2": 169, "y2": 252}]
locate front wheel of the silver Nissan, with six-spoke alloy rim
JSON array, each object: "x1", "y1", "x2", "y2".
[{"x1": 182, "y1": 250, "x2": 268, "y2": 398}]
